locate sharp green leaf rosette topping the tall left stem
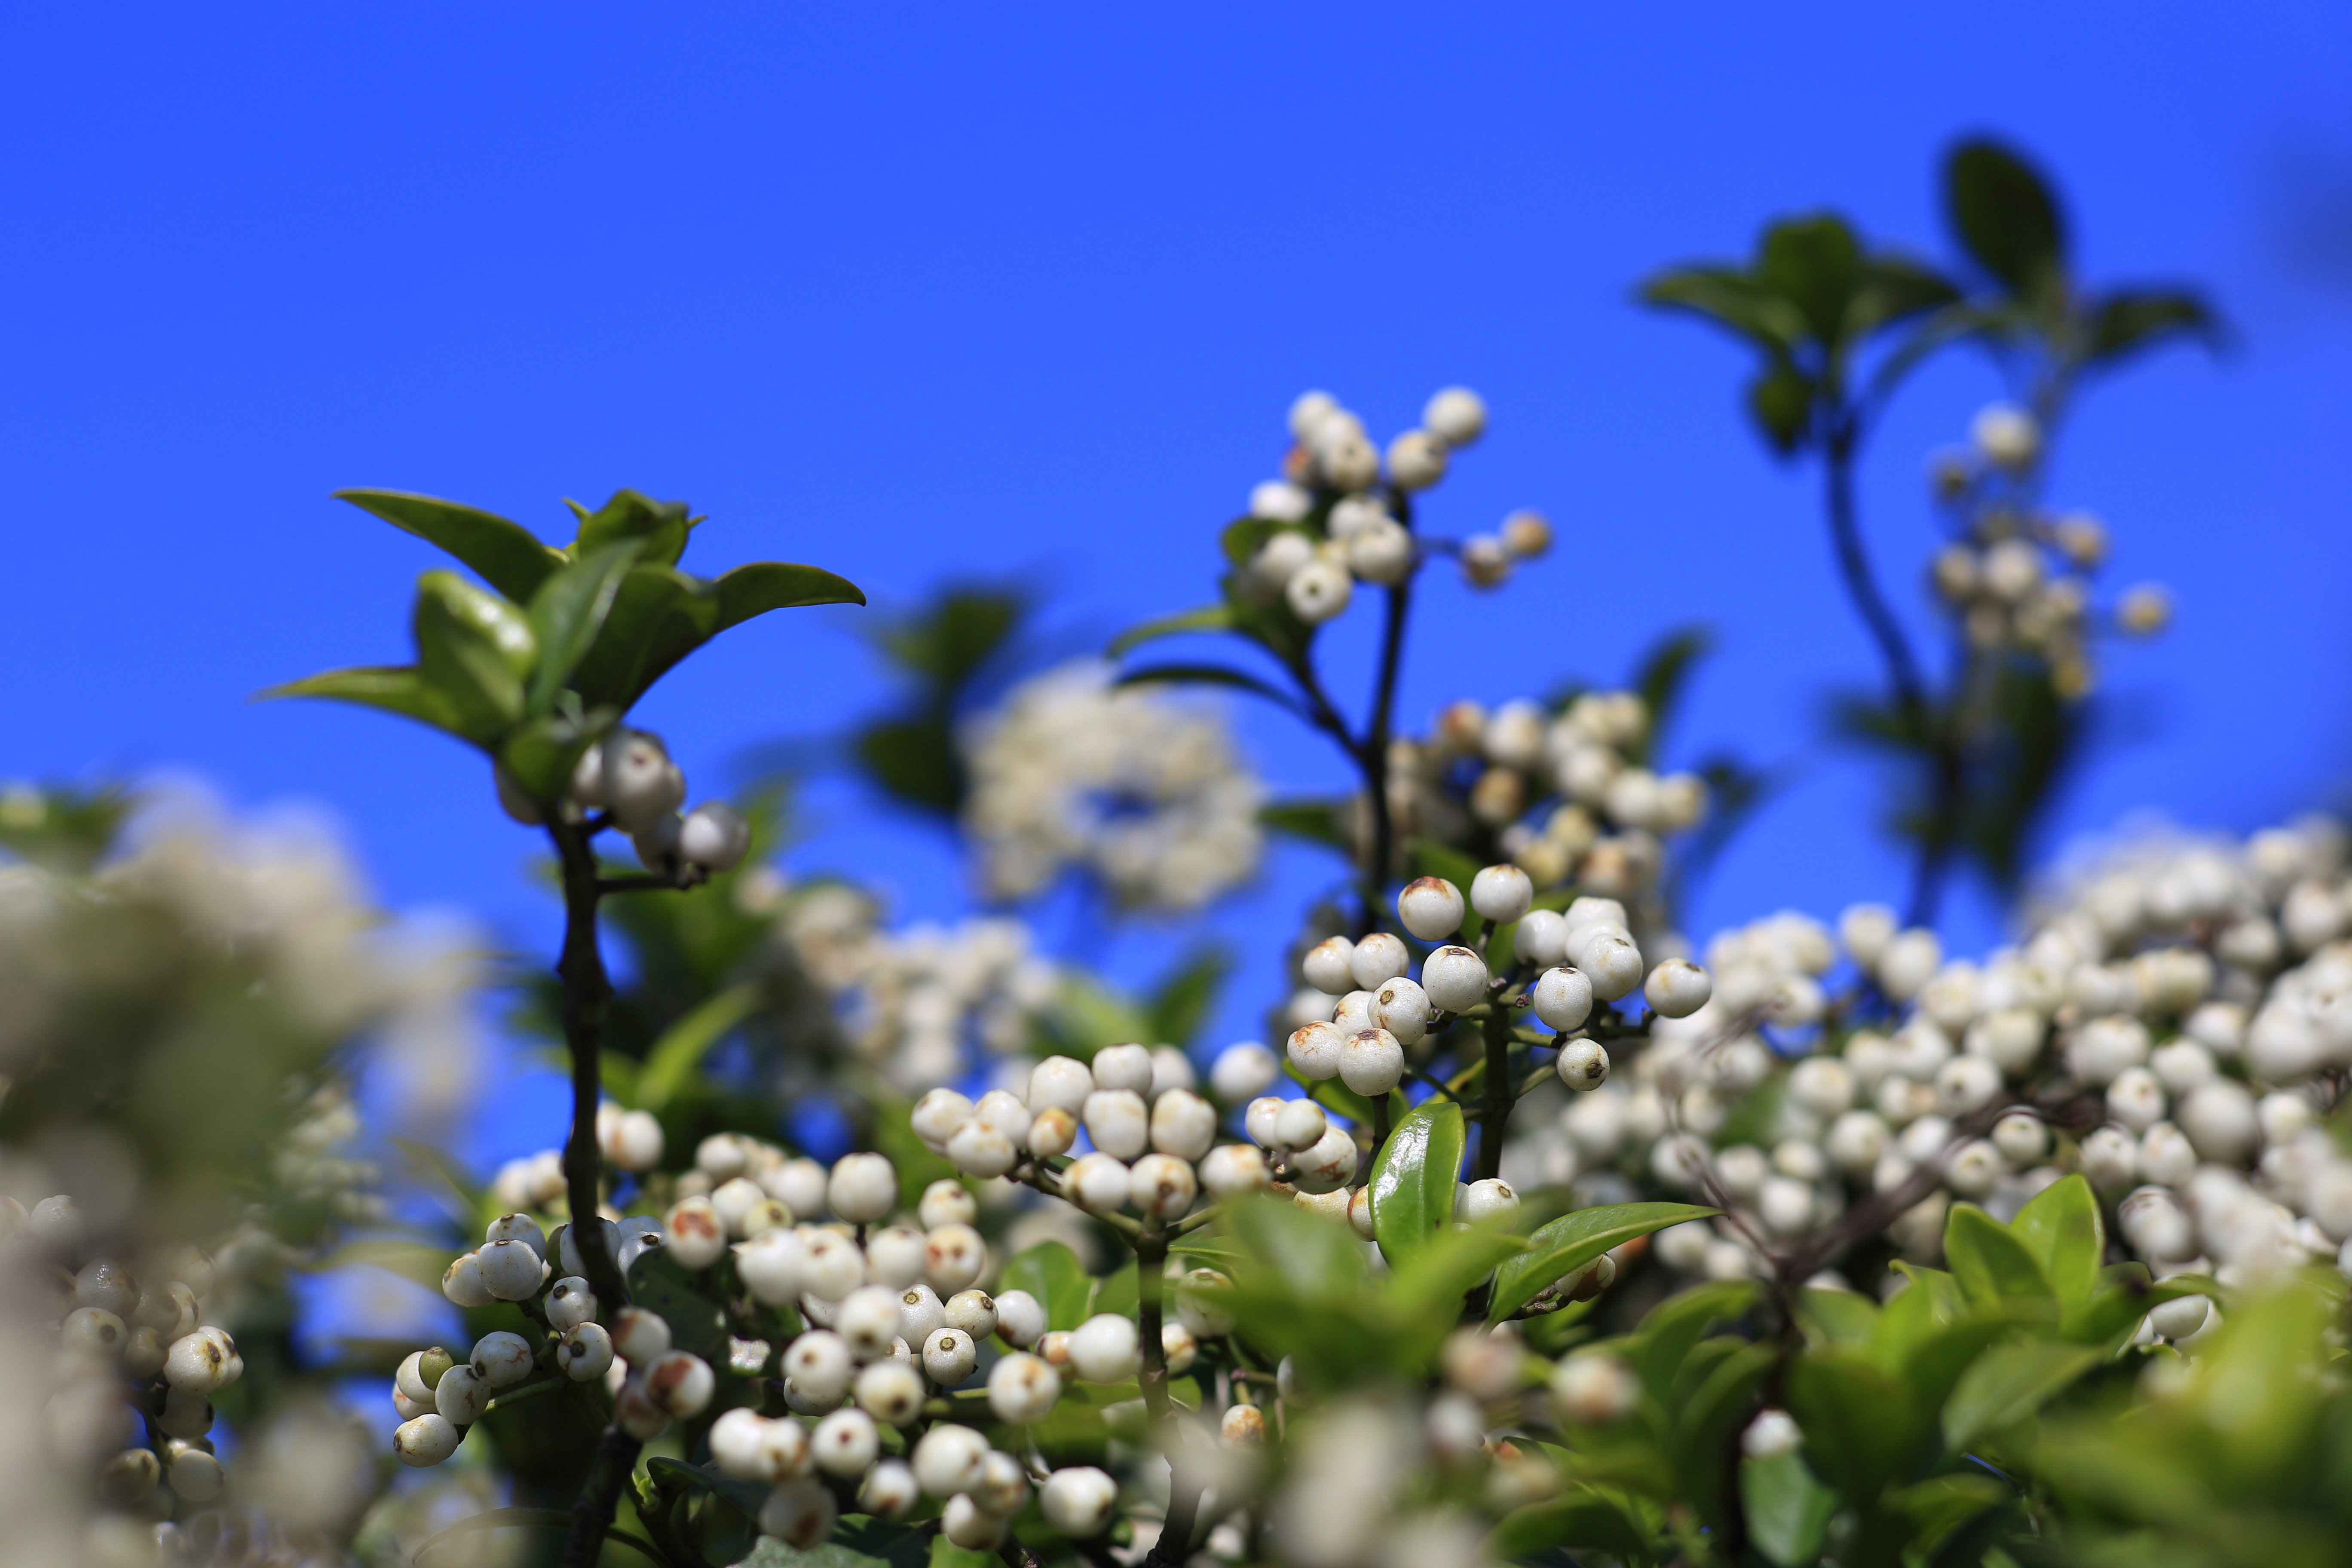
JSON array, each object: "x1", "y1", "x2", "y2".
[{"x1": 263, "y1": 489, "x2": 866, "y2": 811}]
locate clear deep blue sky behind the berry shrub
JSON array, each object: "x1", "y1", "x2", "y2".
[{"x1": 0, "y1": 2, "x2": 2352, "y2": 1166}]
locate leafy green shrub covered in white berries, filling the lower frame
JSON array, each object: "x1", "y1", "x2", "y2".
[{"x1": 18, "y1": 129, "x2": 2352, "y2": 1568}]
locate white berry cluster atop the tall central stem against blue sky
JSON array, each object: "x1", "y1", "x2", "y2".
[{"x1": 1235, "y1": 386, "x2": 1553, "y2": 625}]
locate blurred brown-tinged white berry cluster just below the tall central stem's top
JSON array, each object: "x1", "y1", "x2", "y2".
[{"x1": 1387, "y1": 691, "x2": 1708, "y2": 903}]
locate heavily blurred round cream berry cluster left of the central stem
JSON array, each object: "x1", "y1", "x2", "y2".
[{"x1": 962, "y1": 658, "x2": 1265, "y2": 910}]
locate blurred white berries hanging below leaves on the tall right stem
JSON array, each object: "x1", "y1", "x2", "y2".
[{"x1": 1929, "y1": 404, "x2": 2171, "y2": 696}]
